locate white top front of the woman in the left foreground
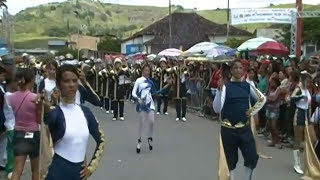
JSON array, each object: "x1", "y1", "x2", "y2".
[{"x1": 54, "y1": 104, "x2": 89, "y2": 163}]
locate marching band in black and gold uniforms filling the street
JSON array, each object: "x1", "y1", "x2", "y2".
[{"x1": 16, "y1": 54, "x2": 192, "y2": 122}]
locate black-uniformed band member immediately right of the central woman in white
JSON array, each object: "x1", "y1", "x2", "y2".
[{"x1": 156, "y1": 57, "x2": 170, "y2": 115}]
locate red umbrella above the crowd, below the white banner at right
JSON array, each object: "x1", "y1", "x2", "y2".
[{"x1": 257, "y1": 41, "x2": 289, "y2": 55}]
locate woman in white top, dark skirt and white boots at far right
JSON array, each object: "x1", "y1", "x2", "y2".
[{"x1": 291, "y1": 71, "x2": 311, "y2": 174}]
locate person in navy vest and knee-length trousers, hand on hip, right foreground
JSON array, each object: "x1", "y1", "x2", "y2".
[{"x1": 213, "y1": 60, "x2": 266, "y2": 180}]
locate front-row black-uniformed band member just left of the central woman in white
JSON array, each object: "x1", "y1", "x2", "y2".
[{"x1": 112, "y1": 58, "x2": 129, "y2": 121}]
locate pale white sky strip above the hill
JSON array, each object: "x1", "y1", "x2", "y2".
[{"x1": 7, "y1": 0, "x2": 320, "y2": 14}]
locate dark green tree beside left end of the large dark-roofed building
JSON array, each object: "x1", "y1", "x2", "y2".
[{"x1": 98, "y1": 36, "x2": 121, "y2": 52}]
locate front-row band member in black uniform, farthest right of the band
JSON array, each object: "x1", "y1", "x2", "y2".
[{"x1": 173, "y1": 61, "x2": 188, "y2": 122}]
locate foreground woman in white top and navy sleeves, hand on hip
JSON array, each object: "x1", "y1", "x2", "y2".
[{"x1": 44, "y1": 65, "x2": 105, "y2": 180}]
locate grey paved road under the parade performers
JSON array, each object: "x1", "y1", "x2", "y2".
[{"x1": 3, "y1": 103, "x2": 300, "y2": 180}]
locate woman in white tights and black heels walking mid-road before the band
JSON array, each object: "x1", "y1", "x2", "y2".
[{"x1": 132, "y1": 64, "x2": 169, "y2": 154}]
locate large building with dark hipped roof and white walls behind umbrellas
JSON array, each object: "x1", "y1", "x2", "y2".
[{"x1": 121, "y1": 12, "x2": 253, "y2": 54}]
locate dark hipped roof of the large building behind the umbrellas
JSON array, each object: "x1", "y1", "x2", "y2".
[{"x1": 124, "y1": 12, "x2": 253, "y2": 44}]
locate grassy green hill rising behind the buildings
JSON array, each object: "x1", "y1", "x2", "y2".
[{"x1": 14, "y1": 0, "x2": 320, "y2": 48}]
